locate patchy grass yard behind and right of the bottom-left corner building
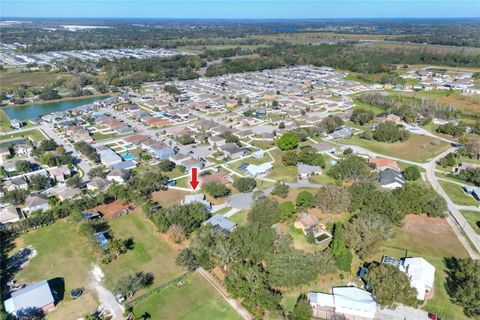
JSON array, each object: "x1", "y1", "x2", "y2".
[{"x1": 11, "y1": 221, "x2": 98, "y2": 320}]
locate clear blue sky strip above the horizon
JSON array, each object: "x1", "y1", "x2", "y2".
[{"x1": 0, "y1": 0, "x2": 480, "y2": 19}]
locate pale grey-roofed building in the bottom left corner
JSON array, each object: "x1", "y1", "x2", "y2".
[{"x1": 4, "y1": 280, "x2": 55, "y2": 317}]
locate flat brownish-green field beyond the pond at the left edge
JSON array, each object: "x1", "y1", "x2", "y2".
[{"x1": 0, "y1": 70, "x2": 72, "y2": 89}]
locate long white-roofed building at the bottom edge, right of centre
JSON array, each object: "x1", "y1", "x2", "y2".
[{"x1": 308, "y1": 287, "x2": 377, "y2": 320}]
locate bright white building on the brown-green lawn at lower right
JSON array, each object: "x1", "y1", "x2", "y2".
[{"x1": 402, "y1": 258, "x2": 435, "y2": 300}]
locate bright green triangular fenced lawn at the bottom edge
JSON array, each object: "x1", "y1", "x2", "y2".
[{"x1": 133, "y1": 273, "x2": 241, "y2": 320}]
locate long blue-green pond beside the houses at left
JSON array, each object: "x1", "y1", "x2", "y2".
[{"x1": 3, "y1": 96, "x2": 108, "y2": 120}]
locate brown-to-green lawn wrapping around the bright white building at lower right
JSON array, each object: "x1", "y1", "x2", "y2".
[{"x1": 376, "y1": 215, "x2": 467, "y2": 320}]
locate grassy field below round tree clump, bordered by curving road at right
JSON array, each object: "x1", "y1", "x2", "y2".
[{"x1": 337, "y1": 134, "x2": 449, "y2": 162}]
